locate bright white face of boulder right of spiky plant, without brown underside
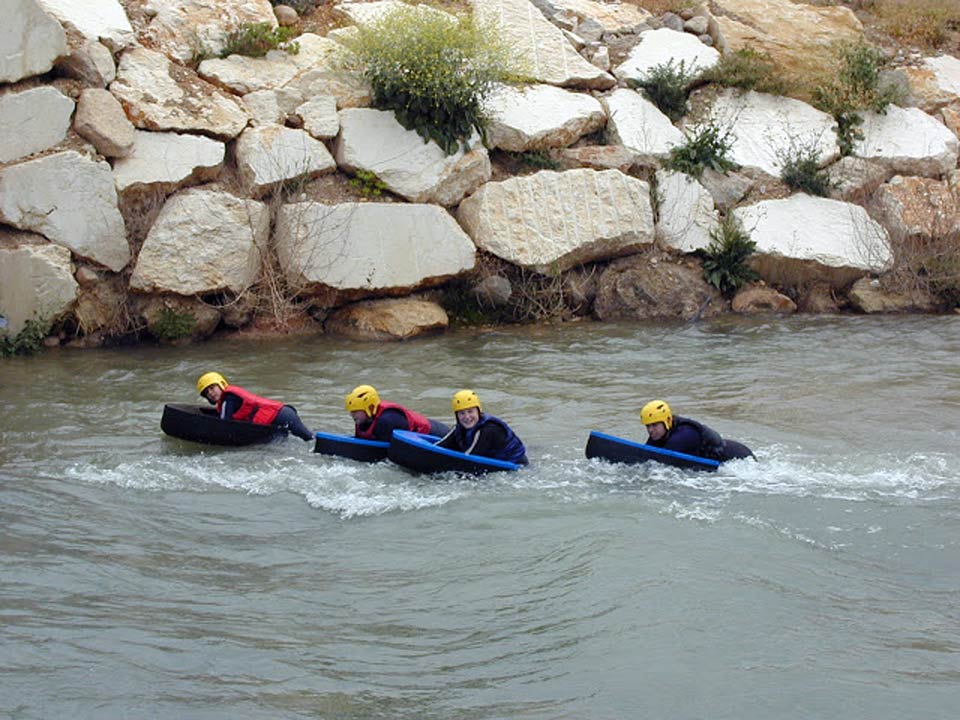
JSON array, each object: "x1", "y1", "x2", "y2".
[{"x1": 733, "y1": 194, "x2": 892, "y2": 272}]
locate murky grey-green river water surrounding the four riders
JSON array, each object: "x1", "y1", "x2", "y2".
[{"x1": 0, "y1": 317, "x2": 960, "y2": 720}]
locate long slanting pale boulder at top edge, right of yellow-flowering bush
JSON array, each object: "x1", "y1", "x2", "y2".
[{"x1": 470, "y1": 0, "x2": 616, "y2": 90}]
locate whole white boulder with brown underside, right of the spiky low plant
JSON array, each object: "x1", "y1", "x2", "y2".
[{"x1": 733, "y1": 194, "x2": 892, "y2": 288}]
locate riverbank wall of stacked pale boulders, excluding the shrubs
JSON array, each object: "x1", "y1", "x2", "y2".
[{"x1": 0, "y1": 0, "x2": 960, "y2": 347}]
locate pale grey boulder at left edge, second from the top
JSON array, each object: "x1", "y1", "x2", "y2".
[{"x1": 0, "y1": 87, "x2": 74, "y2": 163}]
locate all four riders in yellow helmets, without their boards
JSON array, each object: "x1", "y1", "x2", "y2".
[{"x1": 197, "y1": 372, "x2": 752, "y2": 465}]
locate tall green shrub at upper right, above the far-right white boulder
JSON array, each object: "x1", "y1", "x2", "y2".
[{"x1": 813, "y1": 43, "x2": 901, "y2": 156}]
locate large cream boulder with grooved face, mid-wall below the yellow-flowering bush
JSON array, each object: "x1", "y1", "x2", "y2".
[{"x1": 457, "y1": 170, "x2": 654, "y2": 274}]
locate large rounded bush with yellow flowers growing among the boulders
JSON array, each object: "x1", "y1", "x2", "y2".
[{"x1": 344, "y1": 5, "x2": 520, "y2": 155}]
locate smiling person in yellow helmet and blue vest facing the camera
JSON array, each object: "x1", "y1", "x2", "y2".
[{"x1": 437, "y1": 390, "x2": 528, "y2": 465}]
